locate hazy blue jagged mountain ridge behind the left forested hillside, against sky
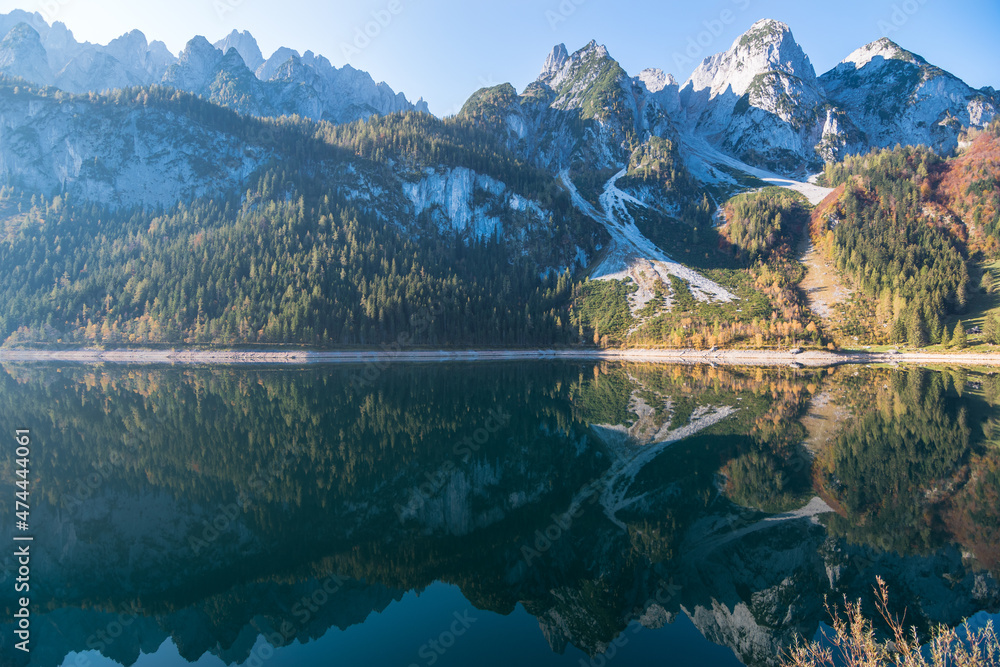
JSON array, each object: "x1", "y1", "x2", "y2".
[{"x1": 0, "y1": 10, "x2": 427, "y2": 123}]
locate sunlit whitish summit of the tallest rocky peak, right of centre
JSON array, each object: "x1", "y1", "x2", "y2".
[{"x1": 684, "y1": 19, "x2": 816, "y2": 96}]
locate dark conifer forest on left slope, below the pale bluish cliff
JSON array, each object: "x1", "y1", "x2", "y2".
[{"x1": 0, "y1": 168, "x2": 576, "y2": 346}]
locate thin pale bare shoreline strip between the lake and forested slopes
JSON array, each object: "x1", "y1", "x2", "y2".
[{"x1": 0, "y1": 349, "x2": 1000, "y2": 368}]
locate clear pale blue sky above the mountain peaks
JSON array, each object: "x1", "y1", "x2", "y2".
[{"x1": 0, "y1": 0, "x2": 1000, "y2": 115}]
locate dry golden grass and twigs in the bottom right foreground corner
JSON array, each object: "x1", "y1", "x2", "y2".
[{"x1": 782, "y1": 578, "x2": 1000, "y2": 667}]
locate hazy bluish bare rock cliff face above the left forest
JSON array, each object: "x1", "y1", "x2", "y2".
[{"x1": 0, "y1": 78, "x2": 278, "y2": 207}]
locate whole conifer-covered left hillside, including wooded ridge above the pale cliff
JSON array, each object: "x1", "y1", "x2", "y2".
[{"x1": 0, "y1": 82, "x2": 601, "y2": 346}]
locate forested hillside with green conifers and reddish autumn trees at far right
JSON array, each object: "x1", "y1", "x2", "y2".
[{"x1": 812, "y1": 121, "x2": 1000, "y2": 346}]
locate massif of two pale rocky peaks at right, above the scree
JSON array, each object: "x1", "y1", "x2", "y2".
[{"x1": 680, "y1": 19, "x2": 1000, "y2": 174}]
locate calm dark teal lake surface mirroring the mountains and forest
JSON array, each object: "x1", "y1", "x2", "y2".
[{"x1": 0, "y1": 362, "x2": 1000, "y2": 667}]
